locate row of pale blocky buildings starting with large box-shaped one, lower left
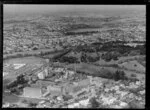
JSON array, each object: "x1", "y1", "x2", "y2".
[{"x1": 23, "y1": 79, "x2": 90, "y2": 98}]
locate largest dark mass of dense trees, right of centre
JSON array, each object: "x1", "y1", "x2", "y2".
[{"x1": 75, "y1": 41, "x2": 146, "y2": 62}]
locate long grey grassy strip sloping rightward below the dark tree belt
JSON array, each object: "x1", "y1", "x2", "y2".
[{"x1": 66, "y1": 59, "x2": 145, "y2": 79}]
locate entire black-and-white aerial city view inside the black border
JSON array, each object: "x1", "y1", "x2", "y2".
[{"x1": 2, "y1": 4, "x2": 146, "y2": 109}]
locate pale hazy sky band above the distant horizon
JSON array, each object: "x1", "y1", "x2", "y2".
[{"x1": 4, "y1": 4, "x2": 145, "y2": 14}]
